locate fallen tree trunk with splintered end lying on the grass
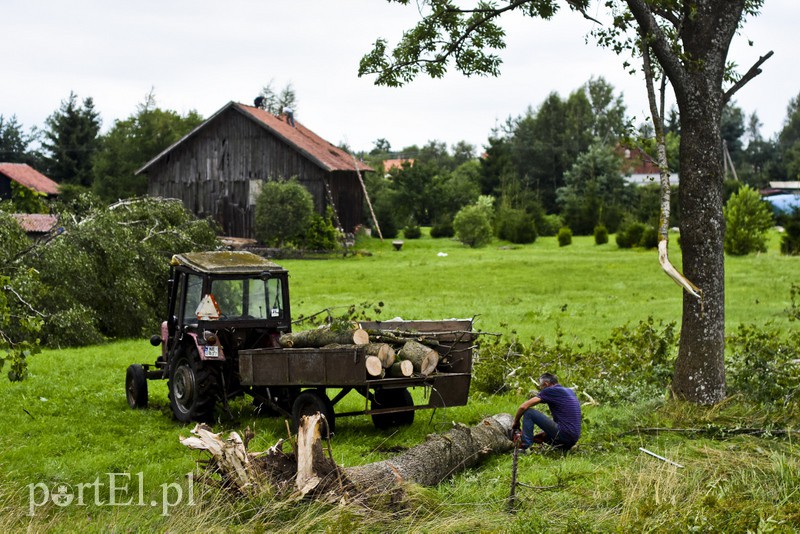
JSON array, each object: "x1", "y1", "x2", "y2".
[{"x1": 181, "y1": 414, "x2": 513, "y2": 506}]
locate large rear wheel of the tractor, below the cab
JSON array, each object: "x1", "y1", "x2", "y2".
[{"x1": 169, "y1": 349, "x2": 217, "y2": 423}]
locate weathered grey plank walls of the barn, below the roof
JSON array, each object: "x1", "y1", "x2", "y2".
[{"x1": 148, "y1": 109, "x2": 362, "y2": 237}]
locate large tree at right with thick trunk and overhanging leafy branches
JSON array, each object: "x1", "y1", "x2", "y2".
[{"x1": 359, "y1": 0, "x2": 769, "y2": 403}]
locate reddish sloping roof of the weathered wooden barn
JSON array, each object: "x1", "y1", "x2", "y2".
[{"x1": 136, "y1": 102, "x2": 372, "y2": 174}]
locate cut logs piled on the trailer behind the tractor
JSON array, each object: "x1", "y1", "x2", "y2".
[{"x1": 279, "y1": 323, "x2": 440, "y2": 379}]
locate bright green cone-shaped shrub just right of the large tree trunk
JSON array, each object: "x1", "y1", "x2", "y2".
[{"x1": 722, "y1": 186, "x2": 772, "y2": 256}]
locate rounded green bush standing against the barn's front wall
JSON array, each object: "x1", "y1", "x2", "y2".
[{"x1": 254, "y1": 179, "x2": 314, "y2": 247}]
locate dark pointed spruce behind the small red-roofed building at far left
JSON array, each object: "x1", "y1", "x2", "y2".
[{"x1": 42, "y1": 92, "x2": 100, "y2": 187}]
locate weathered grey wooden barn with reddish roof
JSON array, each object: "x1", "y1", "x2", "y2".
[{"x1": 137, "y1": 102, "x2": 372, "y2": 237}]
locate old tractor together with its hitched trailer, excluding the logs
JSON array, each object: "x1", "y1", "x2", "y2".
[{"x1": 125, "y1": 251, "x2": 476, "y2": 432}]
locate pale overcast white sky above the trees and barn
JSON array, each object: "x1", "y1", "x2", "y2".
[{"x1": 0, "y1": 0, "x2": 800, "y2": 155}]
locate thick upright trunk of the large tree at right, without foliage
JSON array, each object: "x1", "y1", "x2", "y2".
[{"x1": 662, "y1": 0, "x2": 744, "y2": 404}]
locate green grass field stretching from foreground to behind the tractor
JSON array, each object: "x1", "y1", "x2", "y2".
[{"x1": 0, "y1": 232, "x2": 800, "y2": 532}]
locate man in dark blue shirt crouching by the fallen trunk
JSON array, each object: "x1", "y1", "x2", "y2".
[{"x1": 512, "y1": 373, "x2": 581, "y2": 450}]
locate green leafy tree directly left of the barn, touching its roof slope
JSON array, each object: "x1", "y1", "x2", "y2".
[{"x1": 93, "y1": 91, "x2": 203, "y2": 202}]
